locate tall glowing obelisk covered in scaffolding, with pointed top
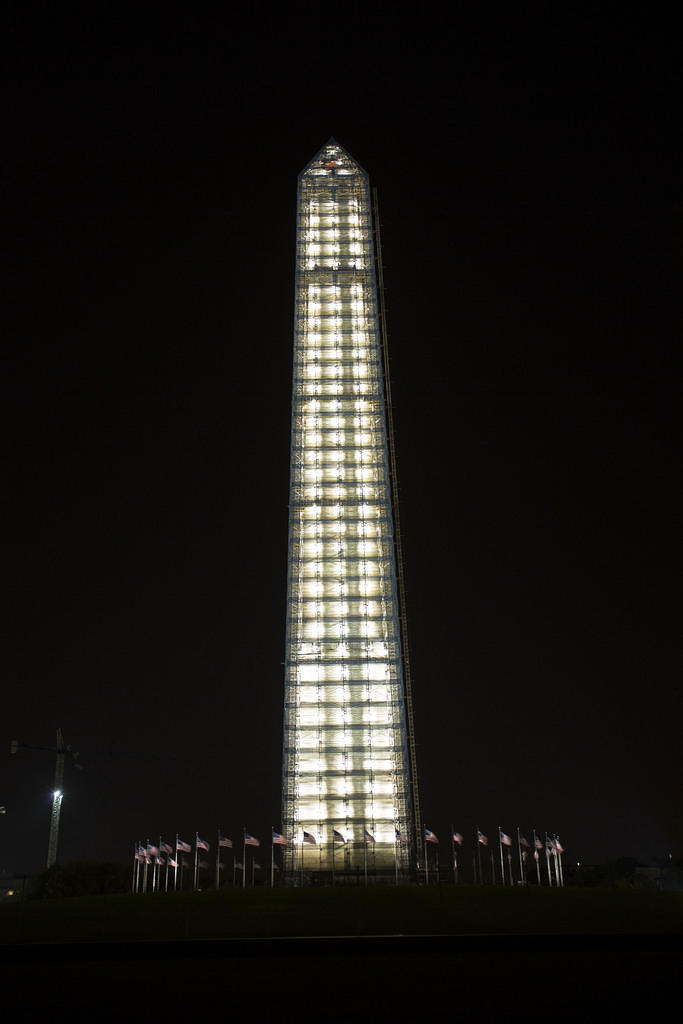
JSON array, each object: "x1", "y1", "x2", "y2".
[{"x1": 283, "y1": 139, "x2": 422, "y2": 880}]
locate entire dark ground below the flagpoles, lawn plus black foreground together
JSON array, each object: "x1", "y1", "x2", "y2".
[{"x1": 0, "y1": 886, "x2": 683, "y2": 1021}]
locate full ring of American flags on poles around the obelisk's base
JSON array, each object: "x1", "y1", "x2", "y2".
[{"x1": 132, "y1": 825, "x2": 564, "y2": 892}]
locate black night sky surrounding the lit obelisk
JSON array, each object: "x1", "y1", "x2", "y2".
[{"x1": 0, "y1": 3, "x2": 683, "y2": 872}]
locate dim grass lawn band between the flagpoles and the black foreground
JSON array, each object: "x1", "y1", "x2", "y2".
[{"x1": 0, "y1": 886, "x2": 683, "y2": 944}]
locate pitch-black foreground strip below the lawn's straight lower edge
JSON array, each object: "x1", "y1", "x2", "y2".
[{"x1": 3, "y1": 936, "x2": 683, "y2": 1021}]
